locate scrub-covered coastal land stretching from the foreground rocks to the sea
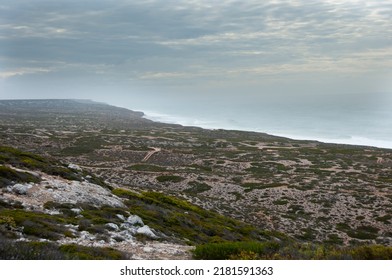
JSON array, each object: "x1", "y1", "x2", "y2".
[{"x1": 0, "y1": 100, "x2": 392, "y2": 258}]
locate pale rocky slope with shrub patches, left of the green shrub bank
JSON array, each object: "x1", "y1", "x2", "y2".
[{"x1": 0, "y1": 150, "x2": 192, "y2": 259}]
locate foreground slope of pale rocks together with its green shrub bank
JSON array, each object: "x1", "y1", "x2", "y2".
[{"x1": 0, "y1": 146, "x2": 283, "y2": 259}]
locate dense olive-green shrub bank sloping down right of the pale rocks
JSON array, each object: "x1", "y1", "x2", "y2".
[{"x1": 113, "y1": 189, "x2": 280, "y2": 244}]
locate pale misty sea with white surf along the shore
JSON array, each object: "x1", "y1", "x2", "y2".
[{"x1": 120, "y1": 92, "x2": 392, "y2": 148}]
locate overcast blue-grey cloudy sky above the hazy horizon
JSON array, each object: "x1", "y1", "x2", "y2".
[{"x1": 0, "y1": 0, "x2": 392, "y2": 108}]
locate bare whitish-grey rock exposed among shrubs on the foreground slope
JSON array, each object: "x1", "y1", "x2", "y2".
[{"x1": 0, "y1": 166, "x2": 192, "y2": 259}]
